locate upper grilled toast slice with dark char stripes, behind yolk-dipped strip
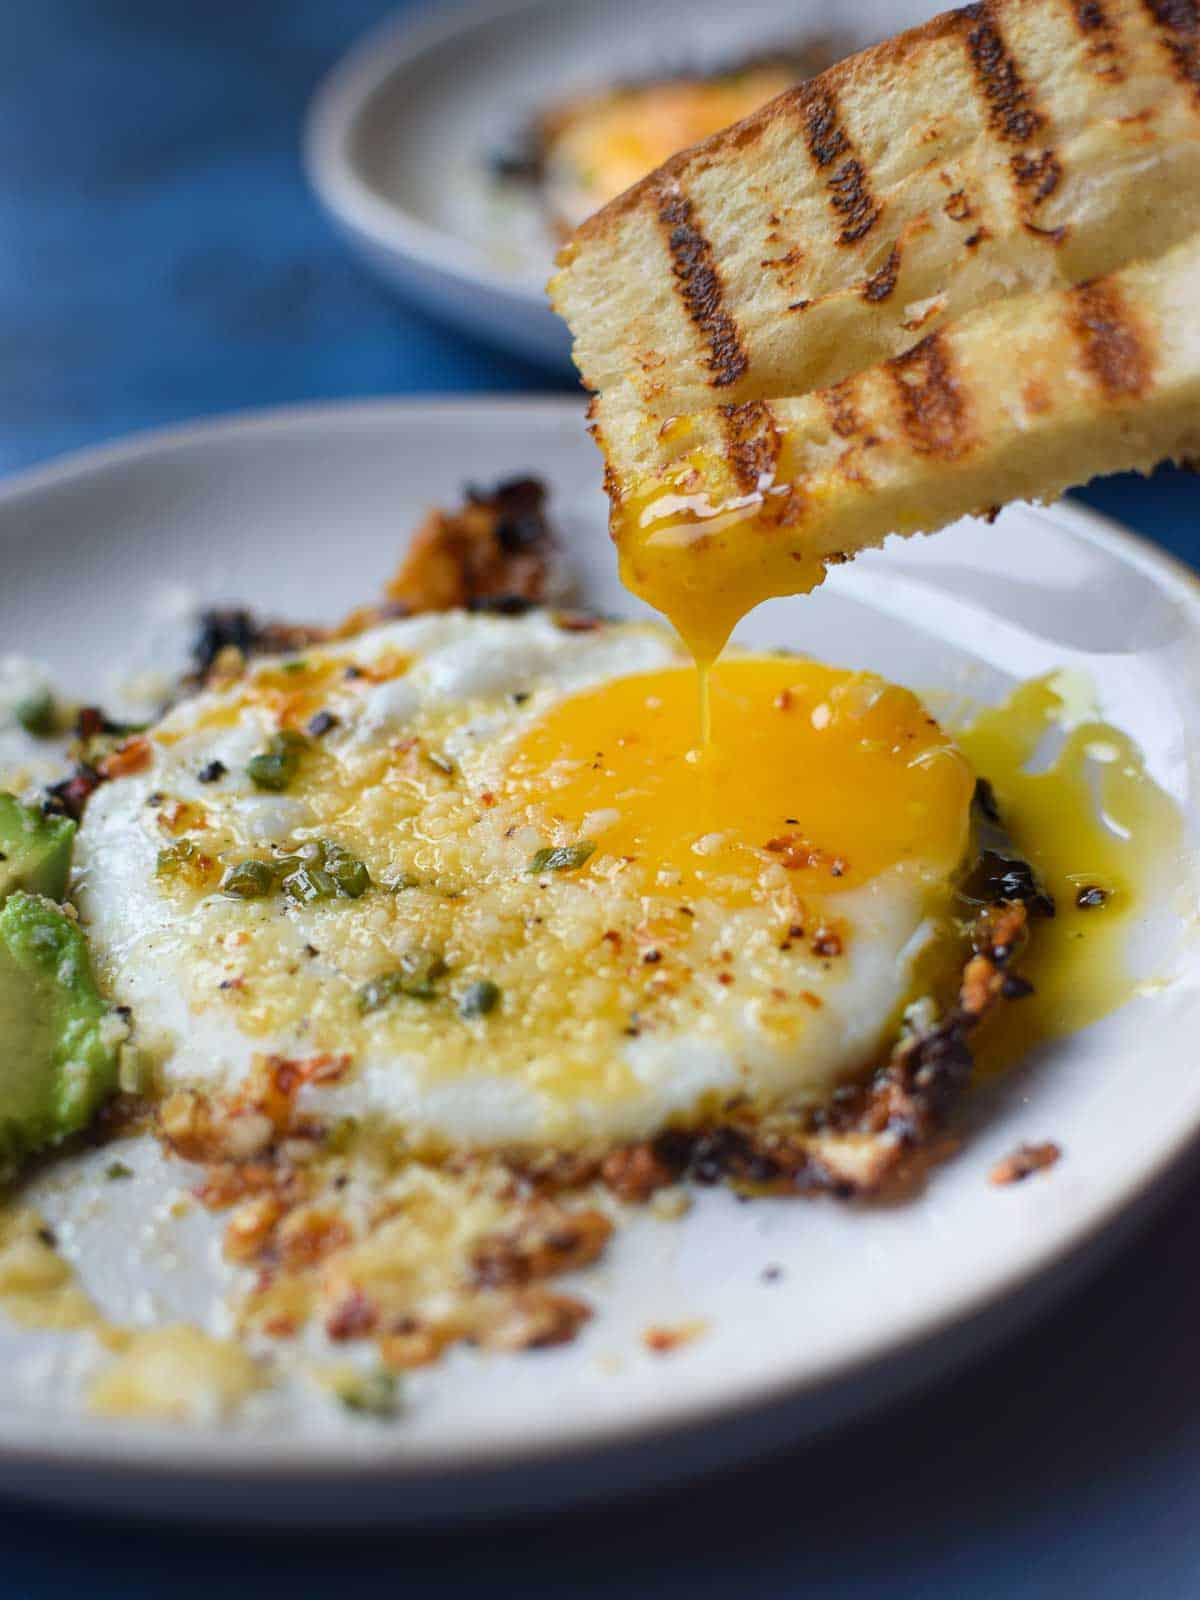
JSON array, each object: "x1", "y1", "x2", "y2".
[{"x1": 550, "y1": 0, "x2": 1200, "y2": 443}]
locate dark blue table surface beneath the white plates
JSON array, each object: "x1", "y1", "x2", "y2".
[{"x1": 0, "y1": 0, "x2": 1200, "y2": 1600}]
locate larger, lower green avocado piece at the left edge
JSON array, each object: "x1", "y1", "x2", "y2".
[{"x1": 0, "y1": 890, "x2": 130, "y2": 1179}]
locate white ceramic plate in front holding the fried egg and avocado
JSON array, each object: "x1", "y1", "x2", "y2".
[{"x1": 0, "y1": 400, "x2": 1200, "y2": 1525}]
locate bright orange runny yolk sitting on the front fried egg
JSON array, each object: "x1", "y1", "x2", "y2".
[{"x1": 509, "y1": 656, "x2": 974, "y2": 904}]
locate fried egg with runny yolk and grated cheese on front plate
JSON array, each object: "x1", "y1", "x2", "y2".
[{"x1": 77, "y1": 613, "x2": 974, "y2": 1149}]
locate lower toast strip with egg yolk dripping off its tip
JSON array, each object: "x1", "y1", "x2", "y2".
[{"x1": 610, "y1": 234, "x2": 1200, "y2": 658}]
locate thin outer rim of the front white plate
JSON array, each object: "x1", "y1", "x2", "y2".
[{"x1": 0, "y1": 390, "x2": 1200, "y2": 1485}]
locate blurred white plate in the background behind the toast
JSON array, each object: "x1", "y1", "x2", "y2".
[{"x1": 306, "y1": 0, "x2": 936, "y2": 370}]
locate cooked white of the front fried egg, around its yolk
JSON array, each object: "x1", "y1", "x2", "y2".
[{"x1": 75, "y1": 614, "x2": 960, "y2": 1146}]
